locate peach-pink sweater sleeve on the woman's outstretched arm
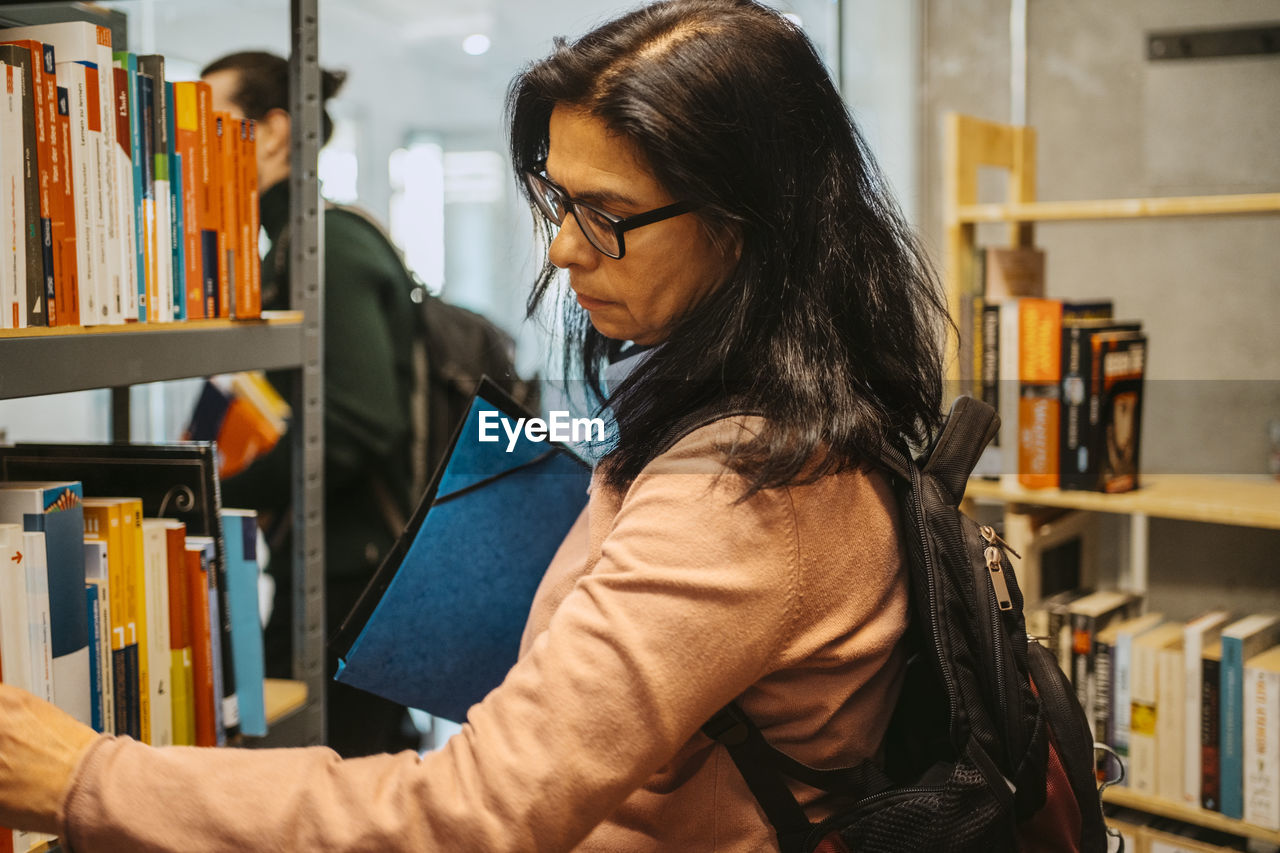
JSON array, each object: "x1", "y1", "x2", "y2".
[{"x1": 63, "y1": 425, "x2": 797, "y2": 853}]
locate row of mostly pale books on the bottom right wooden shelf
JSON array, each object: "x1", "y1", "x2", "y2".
[{"x1": 1027, "y1": 590, "x2": 1280, "y2": 830}]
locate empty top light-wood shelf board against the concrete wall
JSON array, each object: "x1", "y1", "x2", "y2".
[{"x1": 956, "y1": 192, "x2": 1280, "y2": 223}]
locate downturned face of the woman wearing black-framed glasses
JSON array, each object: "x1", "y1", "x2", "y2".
[{"x1": 547, "y1": 105, "x2": 737, "y2": 345}]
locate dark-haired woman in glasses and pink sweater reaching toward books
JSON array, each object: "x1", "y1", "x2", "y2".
[{"x1": 0, "y1": 0, "x2": 943, "y2": 850}]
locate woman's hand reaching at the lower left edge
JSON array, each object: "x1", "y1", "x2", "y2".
[{"x1": 0, "y1": 684, "x2": 99, "y2": 833}]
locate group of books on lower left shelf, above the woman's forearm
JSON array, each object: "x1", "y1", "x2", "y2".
[{"x1": 0, "y1": 444, "x2": 266, "y2": 758}]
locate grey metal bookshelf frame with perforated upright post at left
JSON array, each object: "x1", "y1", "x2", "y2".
[{"x1": 0, "y1": 0, "x2": 325, "y2": 747}]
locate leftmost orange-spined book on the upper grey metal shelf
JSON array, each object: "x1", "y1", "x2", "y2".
[{"x1": 0, "y1": 39, "x2": 65, "y2": 325}]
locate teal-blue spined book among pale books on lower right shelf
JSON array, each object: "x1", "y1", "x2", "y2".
[{"x1": 1219, "y1": 613, "x2": 1280, "y2": 820}]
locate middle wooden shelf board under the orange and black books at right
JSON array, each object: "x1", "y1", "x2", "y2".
[{"x1": 965, "y1": 474, "x2": 1280, "y2": 530}]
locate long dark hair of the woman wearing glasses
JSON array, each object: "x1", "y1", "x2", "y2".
[{"x1": 507, "y1": 0, "x2": 950, "y2": 496}]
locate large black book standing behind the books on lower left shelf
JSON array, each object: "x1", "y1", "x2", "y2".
[{"x1": 0, "y1": 442, "x2": 239, "y2": 736}]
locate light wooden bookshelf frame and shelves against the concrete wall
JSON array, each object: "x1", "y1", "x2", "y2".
[{"x1": 943, "y1": 113, "x2": 1280, "y2": 844}]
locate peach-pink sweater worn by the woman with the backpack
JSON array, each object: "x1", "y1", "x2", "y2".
[{"x1": 60, "y1": 419, "x2": 908, "y2": 853}]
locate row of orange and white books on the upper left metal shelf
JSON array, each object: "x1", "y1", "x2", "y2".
[{"x1": 0, "y1": 22, "x2": 261, "y2": 328}]
